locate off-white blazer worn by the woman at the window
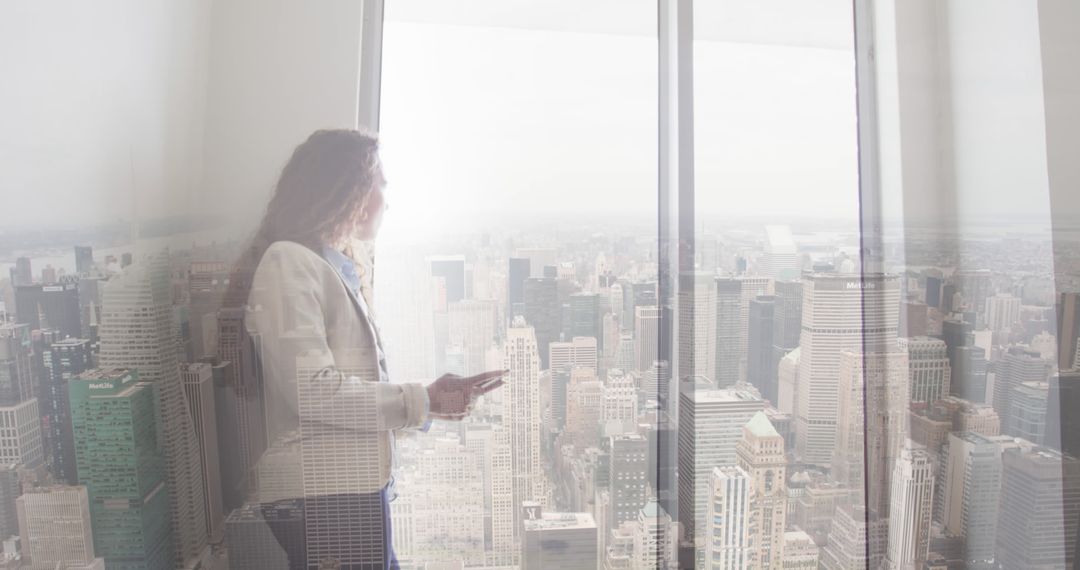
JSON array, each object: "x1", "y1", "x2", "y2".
[{"x1": 245, "y1": 241, "x2": 429, "y2": 502}]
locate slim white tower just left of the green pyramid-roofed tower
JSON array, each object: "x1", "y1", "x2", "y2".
[{"x1": 704, "y1": 465, "x2": 756, "y2": 570}]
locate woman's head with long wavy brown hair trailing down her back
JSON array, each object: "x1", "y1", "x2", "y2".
[{"x1": 222, "y1": 128, "x2": 382, "y2": 308}]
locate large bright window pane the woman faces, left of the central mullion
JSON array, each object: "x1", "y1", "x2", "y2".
[{"x1": 375, "y1": 0, "x2": 656, "y2": 569}]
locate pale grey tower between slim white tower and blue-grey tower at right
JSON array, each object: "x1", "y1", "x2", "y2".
[{"x1": 934, "y1": 432, "x2": 1002, "y2": 568}]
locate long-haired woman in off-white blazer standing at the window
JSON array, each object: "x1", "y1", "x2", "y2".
[{"x1": 232, "y1": 130, "x2": 503, "y2": 570}]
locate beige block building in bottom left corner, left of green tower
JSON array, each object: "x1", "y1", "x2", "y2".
[{"x1": 15, "y1": 486, "x2": 95, "y2": 570}]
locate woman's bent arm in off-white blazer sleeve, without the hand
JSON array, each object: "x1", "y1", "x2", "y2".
[{"x1": 246, "y1": 242, "x2": 429, "y2": 431}]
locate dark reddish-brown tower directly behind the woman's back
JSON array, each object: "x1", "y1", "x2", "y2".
[{"x1": 213, "y1": 307, "x2": 265, "y2": 511}]
